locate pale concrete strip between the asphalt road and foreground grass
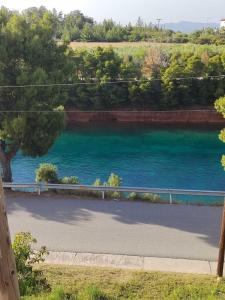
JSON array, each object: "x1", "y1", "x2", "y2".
[{"x1": 45, "y1": 251, "x2": 216, "y2": 275}]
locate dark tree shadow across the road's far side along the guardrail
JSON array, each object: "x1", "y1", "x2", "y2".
[{"x1": 7, "y1": 195, "x2": 222, "y2": 247}]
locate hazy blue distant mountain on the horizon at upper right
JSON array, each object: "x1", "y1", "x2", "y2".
[{"x1": 163, "y1": 21, "x2": 219, "y2": 33}]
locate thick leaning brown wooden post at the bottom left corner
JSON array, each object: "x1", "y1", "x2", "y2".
[{"x1": 0, "y1": 177, "x2": 20, "y2": 300}]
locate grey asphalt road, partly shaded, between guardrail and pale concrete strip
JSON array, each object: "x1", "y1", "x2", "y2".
[{"x1": 6, "y1": 195, "x2": 222, "y2": 260}]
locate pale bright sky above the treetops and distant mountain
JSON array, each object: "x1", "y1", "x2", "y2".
[{"x1": 0, "y1": 0, "x2": 225, "y2": 24}]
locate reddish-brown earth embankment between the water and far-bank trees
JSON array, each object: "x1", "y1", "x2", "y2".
[{"x1": 68, "y1": 109, "x2": 225, "y2": 124}]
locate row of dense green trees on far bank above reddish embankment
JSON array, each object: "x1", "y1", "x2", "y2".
[{"x1": 68, "y1": 47, "x2": 225, "y2": 110}]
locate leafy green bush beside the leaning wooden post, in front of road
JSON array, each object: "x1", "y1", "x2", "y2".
[{"x1": 12, "y1": 232, "x2": 50, "y2": 296}]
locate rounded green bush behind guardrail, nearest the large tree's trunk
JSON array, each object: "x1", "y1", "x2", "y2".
[{"x1": 35, "y1": 163, "x2": 59, "y2": 183}]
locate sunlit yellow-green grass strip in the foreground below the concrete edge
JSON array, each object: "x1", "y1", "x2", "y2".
[{"x1": 22, "y1": 265, "x2": 225, "y2": 300}]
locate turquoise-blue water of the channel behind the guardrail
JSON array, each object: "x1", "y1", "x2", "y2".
[{"x1": 13, "y1": 124, "x2": 225, "y2": 190}]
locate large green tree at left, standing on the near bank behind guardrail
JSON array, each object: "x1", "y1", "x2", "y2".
[{"x1": 0, "y1": 8, "x2": 70, "y2": 182}]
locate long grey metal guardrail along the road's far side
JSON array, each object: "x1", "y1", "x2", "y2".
[{"x1": 3, "y1": 182, "x2": 225, "y2": 204}]
